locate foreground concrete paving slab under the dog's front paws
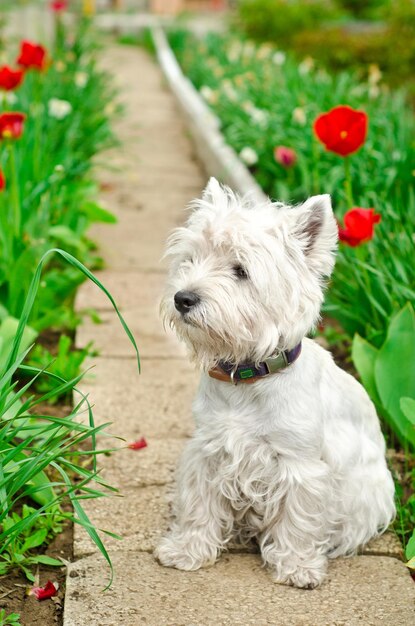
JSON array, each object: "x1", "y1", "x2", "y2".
[{"x1": 64, "y1": 549, "x2": 415, "y2": 626}]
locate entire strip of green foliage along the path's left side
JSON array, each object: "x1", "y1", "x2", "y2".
[{"x1": 0, "y1": 21, "x2": 139, "y2": 584}]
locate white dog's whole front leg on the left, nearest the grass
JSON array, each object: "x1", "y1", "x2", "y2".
[{"x1": 154, "y1": 439, "x2": 233, "y2": 570}]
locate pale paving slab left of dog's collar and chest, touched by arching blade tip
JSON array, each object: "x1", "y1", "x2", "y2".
[{"x1": 74, "y1": 358, "x2": 199, "y2": 441}]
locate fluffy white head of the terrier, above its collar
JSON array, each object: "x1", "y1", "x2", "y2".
[{"x1": 161, "y1": 178, "x2": 337, "y2": 367}]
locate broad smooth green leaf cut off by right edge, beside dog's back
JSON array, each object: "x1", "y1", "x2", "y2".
[{"x1": 375, "y1": 303, "x2": 415, "y2": 448}]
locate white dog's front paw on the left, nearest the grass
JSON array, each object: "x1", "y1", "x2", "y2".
[{"x1": 154, "y1": 535, "x2": 218, "y2": 571}]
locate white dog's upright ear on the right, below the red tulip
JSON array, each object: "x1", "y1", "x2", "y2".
[{"x1": 296, "y1": 194, "x2": 338, "y2": 276}]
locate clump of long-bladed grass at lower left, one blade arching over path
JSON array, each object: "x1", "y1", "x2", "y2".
[{"x1": 0, "y1": 250, "x2": 139, "y2": 584}]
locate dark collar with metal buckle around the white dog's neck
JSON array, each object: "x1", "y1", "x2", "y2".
[{"x1": 208, "y1": 342, "x2": 301, "y2": 385}]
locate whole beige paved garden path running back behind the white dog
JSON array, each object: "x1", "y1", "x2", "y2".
[{"x1": 64, "y1": 46, "x2": 415, "y2": 626}]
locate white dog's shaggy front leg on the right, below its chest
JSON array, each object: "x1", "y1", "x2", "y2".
[{"x1": 260, "y1": 458, "x2": 330, "y2": 589}]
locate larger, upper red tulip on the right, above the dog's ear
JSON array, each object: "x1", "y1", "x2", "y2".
[{"x1": 314, "y1": 105, "x2": 368, "y2": 156}]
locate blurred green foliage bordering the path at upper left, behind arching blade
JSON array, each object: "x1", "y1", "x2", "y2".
[{"x1": 0, "y1": 18, "x2": 115, "y2": 331}]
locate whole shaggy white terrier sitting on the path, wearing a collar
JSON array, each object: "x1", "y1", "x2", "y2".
[{"x1": 155, "y1": 179, "x2": 395, "y2": 588}]
